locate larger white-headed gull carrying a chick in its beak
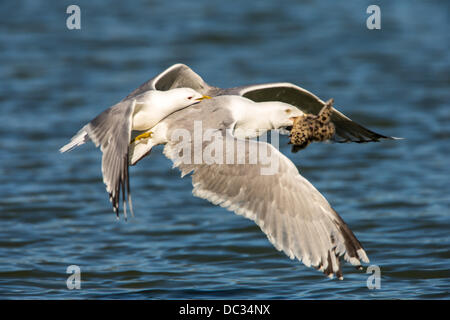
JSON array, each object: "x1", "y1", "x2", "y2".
[{"x1": 130, "y1": 95, "x2": 369, "y2": 279}]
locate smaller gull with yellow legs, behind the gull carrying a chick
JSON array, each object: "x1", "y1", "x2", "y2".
[{"x1": 59, "y1": 88, "x2": 210, "y2": 219}]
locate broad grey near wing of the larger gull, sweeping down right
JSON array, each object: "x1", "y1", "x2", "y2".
[{"x1": 164, "y1": 131, "x2": 369, "y2": 279}]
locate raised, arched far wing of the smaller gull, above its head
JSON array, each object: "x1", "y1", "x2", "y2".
[{"x1": 124, "y1": 63, "x2": 209, "y2": 100}]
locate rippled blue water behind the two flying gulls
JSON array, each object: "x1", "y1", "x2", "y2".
[{"x1": 0, "y1": 0, "x2": 450, "y2": 299}]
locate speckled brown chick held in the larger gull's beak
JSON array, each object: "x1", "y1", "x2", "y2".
[{"x1": 289, "y1": 99, "x2": 335, "y2": 153}]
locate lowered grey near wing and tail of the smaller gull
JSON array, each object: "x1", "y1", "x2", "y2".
[{"x1": 60, "y1": 99, "x2": 136, "y2": 218}]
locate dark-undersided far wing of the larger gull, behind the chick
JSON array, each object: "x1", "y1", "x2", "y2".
[{"x1": 232, "y1": 83, "x2": 393, "y2": 142}]
